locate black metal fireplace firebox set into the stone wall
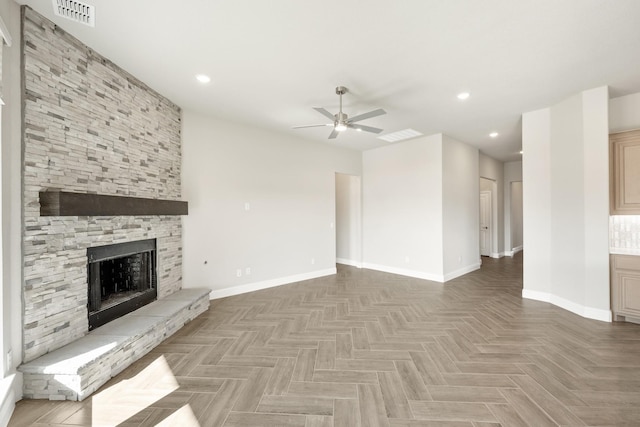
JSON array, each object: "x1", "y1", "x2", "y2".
[{"x1": 87, "y1": 239, "x2": 158, "y2": 330}]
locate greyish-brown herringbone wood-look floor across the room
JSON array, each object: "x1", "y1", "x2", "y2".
[{"x1": 10, "y1": 256, "x2": 640, "y2": 427}]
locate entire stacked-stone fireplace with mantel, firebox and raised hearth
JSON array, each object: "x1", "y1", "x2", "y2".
[{"x1": 18, "y1": 6, "x2": 209, "y2": 400}]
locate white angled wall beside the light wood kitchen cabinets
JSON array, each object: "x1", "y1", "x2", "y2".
[{"x1": 523, "y1": 87, "x2": 611, "y2": 320}]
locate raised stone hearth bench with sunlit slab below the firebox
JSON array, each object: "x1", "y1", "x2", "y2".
[{"x1": 19, "y1": 289, "x2": 209, "y2": 400}]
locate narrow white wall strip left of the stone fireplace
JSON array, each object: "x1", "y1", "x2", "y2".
[{"x1": 0, "y1": 1, "x2": 22, "y2": 425}]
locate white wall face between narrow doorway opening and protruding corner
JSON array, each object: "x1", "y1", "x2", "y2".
[{"x1": 362, "y1": 134, "x2": 443, "y2": 281}]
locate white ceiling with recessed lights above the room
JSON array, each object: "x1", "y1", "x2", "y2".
[{"x1": 13, "y1": 0, "x2": 640, "y2": 161}]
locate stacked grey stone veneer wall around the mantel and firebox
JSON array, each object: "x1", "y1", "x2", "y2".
[{"x1": 22, "y1": 7, "x2": 182, "y2": 361}]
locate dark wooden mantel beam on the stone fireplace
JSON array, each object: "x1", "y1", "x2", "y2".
[{"x1": 40, "y1": 190, "x2": 188, "y2": 216}]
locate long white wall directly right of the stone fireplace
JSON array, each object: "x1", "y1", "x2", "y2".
[{"x1": 182, "y1": 111, "x2": 362, "y2": 298}]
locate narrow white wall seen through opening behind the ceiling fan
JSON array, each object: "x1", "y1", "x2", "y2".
[{"x1": 336, "y1": 173, "x2": 362, "y2": 267}]
